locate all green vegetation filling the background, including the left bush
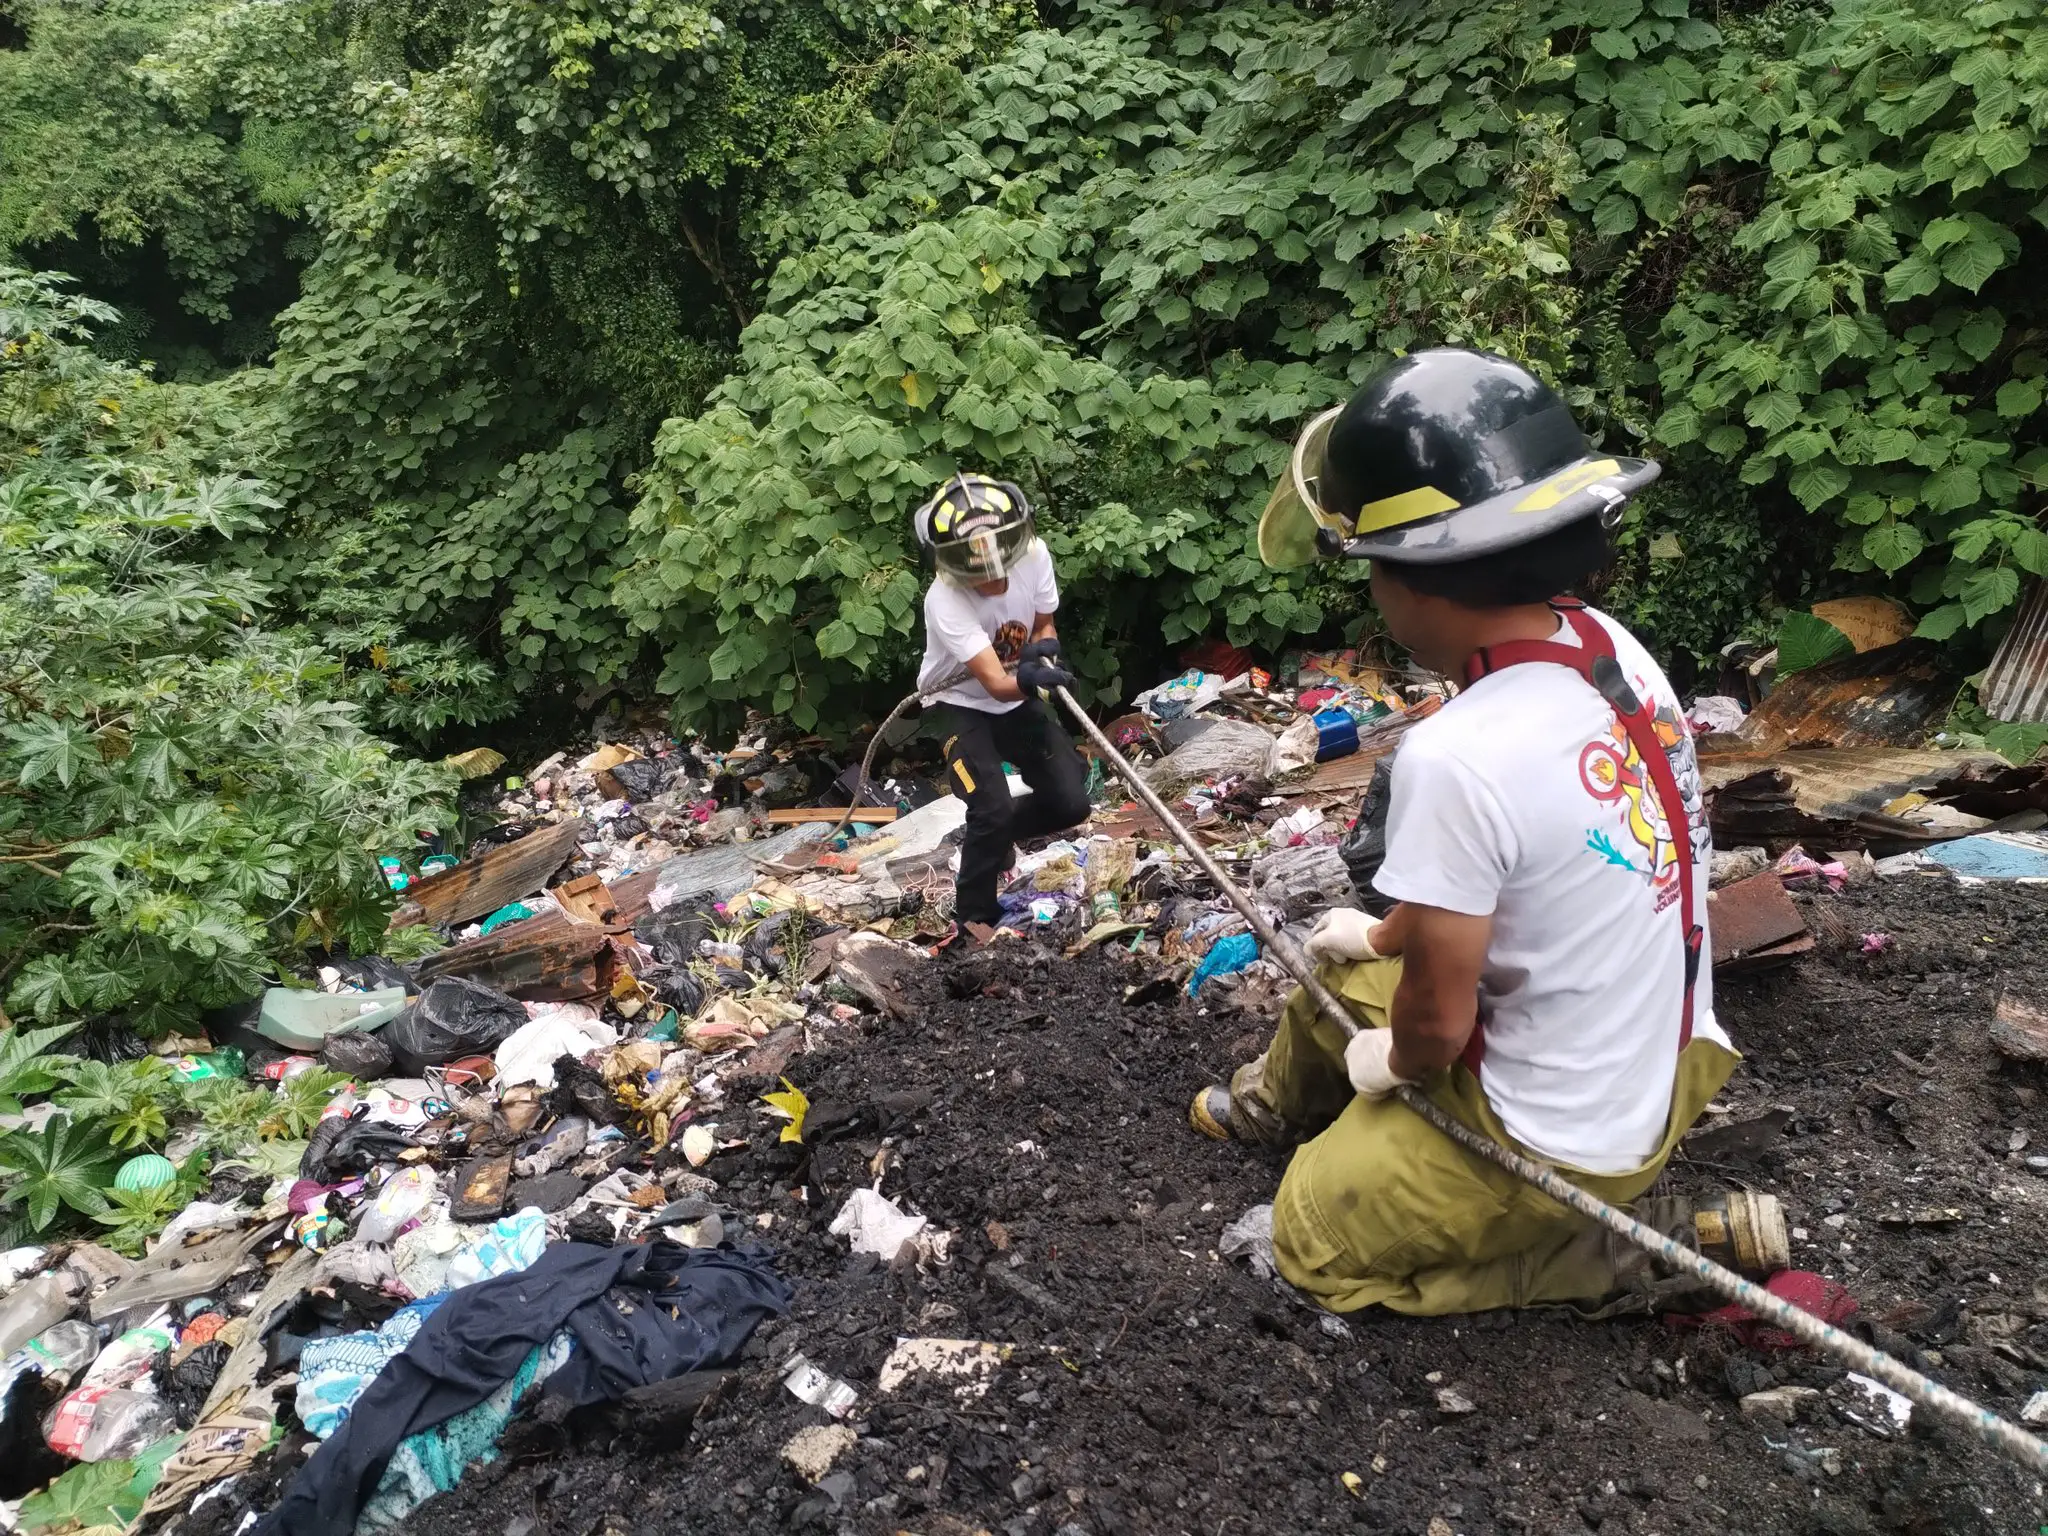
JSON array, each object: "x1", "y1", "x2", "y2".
[{"x1": 0, "y1": 0, "x2": 2048, "y2": 1048}]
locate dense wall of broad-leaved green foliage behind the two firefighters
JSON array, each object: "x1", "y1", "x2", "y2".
[{"x1": 0, "y1": 0, "x2": 2048, "y2": 735}]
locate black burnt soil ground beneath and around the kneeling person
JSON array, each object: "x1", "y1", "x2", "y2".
[{"x1": 387, "y1": 879, "x2": 2048, "y2": 1536}]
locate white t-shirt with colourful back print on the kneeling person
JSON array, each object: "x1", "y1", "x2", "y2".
[{"x1": 1374, "y1": 612, "x2": 1729, "y2": 1174}]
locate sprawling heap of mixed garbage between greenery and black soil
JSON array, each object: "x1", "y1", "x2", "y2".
[{"x1": 0, "y1": 606, "x2": 2048, "y2": 1532}]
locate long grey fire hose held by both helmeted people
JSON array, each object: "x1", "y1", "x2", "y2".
[{"x1": 1059, "y1": 688, "x2": 2048, "y2": 1475}]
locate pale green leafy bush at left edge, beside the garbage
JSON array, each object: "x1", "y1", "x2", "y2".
[{"x1": 0, "y1": 270, "x2": 453, "y2": 1032}]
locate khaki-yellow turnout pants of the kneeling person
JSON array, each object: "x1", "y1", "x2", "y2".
[{"x1": 1233, "y1": 961, "x2": 1739, "y2": 1317}]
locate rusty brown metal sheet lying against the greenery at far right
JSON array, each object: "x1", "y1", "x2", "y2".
[{"x1": 1739, "y1": 641, "x2": 1960, "y2": 750}]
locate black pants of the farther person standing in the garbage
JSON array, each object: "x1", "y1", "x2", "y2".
[{"x1": 940, "y1": 698, "x2": 1087, "y2": 924}]
